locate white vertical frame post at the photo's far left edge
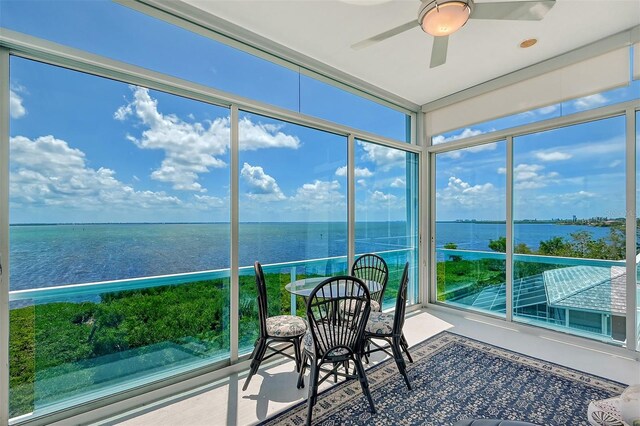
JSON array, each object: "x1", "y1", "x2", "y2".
[{"x1": 0, "y1": 48, "x2": 9, "y2": 425}]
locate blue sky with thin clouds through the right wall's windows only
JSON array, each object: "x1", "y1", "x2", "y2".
[{"x1": 433, "y1": 81, "x2": 640, "y2": 220}]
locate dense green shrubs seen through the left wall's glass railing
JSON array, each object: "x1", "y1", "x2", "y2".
[{"x1": 9, "y1": 264, "x2": 404, "y2": 417}]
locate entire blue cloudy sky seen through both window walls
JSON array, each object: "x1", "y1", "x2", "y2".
[{"x1": 0, "y1": 0, "x2": 639, "y2": 223}]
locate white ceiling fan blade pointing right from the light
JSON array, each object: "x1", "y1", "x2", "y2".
[{"x1": 470, "y1": 0, "x2": 556, "y2": 21}]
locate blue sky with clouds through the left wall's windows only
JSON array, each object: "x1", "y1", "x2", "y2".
[{"x1": 1, "y1": 1, "x2": 416, "y2": 223}]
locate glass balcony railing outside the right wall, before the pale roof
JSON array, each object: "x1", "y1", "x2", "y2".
[{"x1": 436, "y1": 248, "x2": 626, "y2": 345}]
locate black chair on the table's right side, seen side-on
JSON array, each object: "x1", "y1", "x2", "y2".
[{"x1": 364, "y1": 262, "x2": 413, "y2": 390}]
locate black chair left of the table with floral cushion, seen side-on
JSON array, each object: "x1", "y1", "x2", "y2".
[{"x1": 242, "y1": 262, "x2": 307, "y2": 390}]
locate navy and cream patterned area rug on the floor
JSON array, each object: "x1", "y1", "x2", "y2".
[{"x1": 261, "y1": 332, "x2": 626, "y2": 426}]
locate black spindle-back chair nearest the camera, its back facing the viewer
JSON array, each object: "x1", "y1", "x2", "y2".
[{"x1": 298, "y1": 276, "x2": 376, "y2": 425}]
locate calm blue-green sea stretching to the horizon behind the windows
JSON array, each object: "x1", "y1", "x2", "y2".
[{"x1": 10, "y1": 222, "x2": 609, "y2": 290}]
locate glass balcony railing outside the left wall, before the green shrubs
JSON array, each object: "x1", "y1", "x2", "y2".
[{"x1": 9, "y1": 249, "x2": 417, "y2": 418}]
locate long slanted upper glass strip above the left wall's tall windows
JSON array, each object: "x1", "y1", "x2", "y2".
[{"x1": 0, "y1": 0, "x2": 411, "y2": 141}]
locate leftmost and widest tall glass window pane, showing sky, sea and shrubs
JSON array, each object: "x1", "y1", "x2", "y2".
[{"x1": 9, "y1": 57, "x2": 230, "y2": 417}]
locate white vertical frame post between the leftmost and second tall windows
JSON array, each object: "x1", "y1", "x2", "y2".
[{"x1": 229, "y1": 104, "x2": 240, "y2": 364}]
